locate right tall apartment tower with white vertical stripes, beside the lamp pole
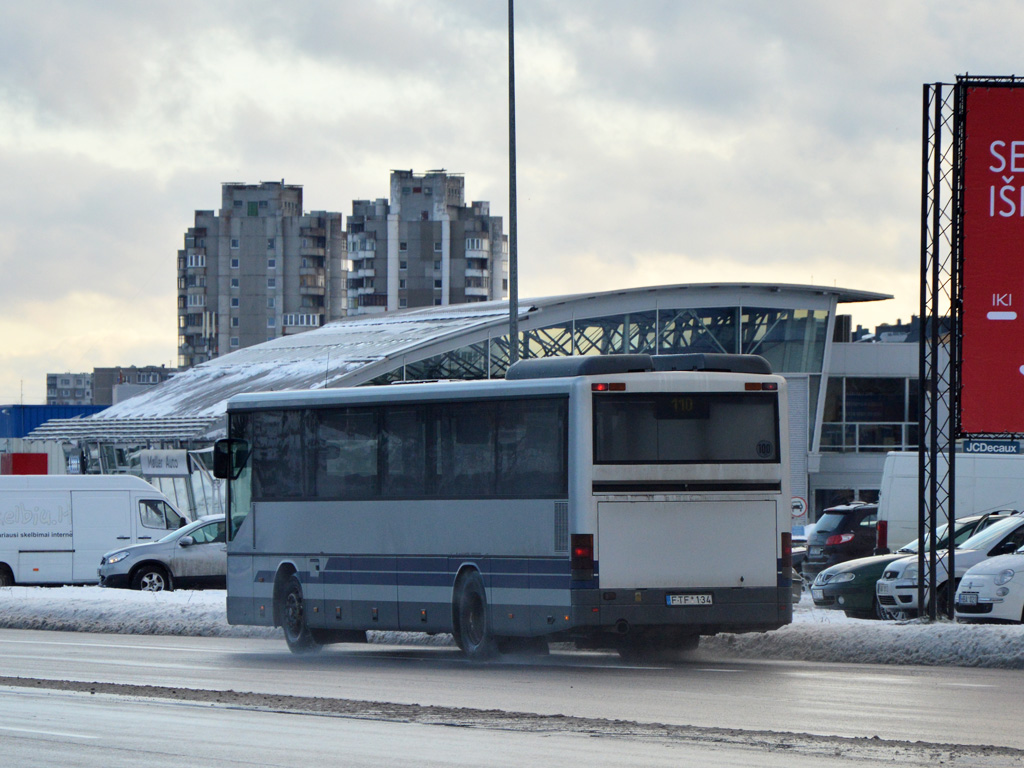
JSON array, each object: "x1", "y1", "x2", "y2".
[{"x1": 348, "y1": 170, "x2": 508, "y2": 314}]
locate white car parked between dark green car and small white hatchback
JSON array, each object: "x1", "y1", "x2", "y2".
[{"x1": 874, "y1": 514, "x2": 1024, "y2": 615}]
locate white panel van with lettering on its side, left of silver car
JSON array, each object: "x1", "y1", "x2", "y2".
[{"x1": 0, "y1": 475, "x2": 189, "y2": 587}]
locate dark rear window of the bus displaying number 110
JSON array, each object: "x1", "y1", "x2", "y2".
[{"x1": 594, "y1": 392, "x2": 779, "y2": 464}]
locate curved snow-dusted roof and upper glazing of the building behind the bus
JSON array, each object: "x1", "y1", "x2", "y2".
[{"x1": 93, "y1": 284, "x2": 892, "y2": 423}]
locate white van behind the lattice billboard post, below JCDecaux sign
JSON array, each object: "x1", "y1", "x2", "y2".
[{"x1": 876, "y1": 451, "x2": 1024, "y2": 553}]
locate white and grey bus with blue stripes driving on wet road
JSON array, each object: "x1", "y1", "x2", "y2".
[{"x1": 215, "y1": 354, "x2": 793, "y2": 658}]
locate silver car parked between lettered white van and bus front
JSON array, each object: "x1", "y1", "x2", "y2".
[{"x1": 99, "y1": 515, "x2": 227, "y2": 592}]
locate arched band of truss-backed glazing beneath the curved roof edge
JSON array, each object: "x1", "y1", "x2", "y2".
[{"x1": 368, "y1": 306, "x2": 828, "y2": 384}]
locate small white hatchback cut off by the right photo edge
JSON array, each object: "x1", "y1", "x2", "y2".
[{"x1": 953, "y1": 548, "x2": 1024, "y2": 624}]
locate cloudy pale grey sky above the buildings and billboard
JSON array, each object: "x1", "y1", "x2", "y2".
[{"x1": 0, "y1": 0, "x2": 1011, "y2": 402}]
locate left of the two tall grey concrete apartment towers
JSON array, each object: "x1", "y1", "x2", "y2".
[{"x1": 178, "y1": 180, "x2": 348, "y2": 369}]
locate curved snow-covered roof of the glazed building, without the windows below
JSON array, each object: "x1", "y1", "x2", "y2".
[{"x1": 93, "y1": 283, "x2": 892, "y2": 421}]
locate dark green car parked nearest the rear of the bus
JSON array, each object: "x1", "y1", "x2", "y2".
[{"x1": 811, "y1": 513, "x2": 1005, "y2": 618}]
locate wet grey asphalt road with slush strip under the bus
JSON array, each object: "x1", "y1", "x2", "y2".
[{"x1": 0, "y1": 630, "x2": 1024, "y2": 766}]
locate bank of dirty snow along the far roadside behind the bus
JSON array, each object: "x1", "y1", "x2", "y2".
[{"x1": 0, "y1": 587, "x2": 1024, "y2": 669}]
